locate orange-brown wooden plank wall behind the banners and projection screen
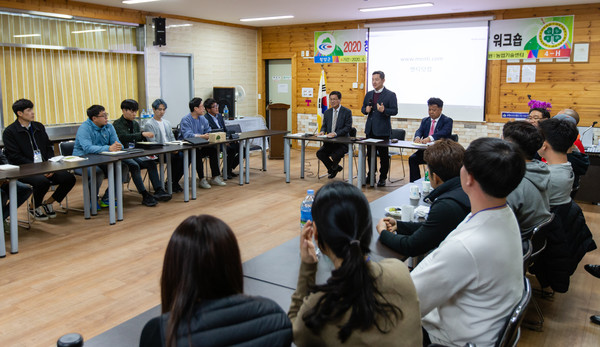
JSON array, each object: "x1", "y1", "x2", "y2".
[{"x1": 259, "y1": 4, "x2": 600, "y2": 126}]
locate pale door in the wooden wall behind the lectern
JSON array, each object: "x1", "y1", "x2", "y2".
[{"x1": 267, "y1": 59, "x2": 292, "y2": 131}]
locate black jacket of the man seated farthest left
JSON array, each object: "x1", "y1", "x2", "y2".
[{"x1": 2, "y1": 120, "x2": 54, "y2": 165}]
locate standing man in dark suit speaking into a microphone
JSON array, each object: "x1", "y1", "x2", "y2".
[{"x1": 361, "y1": 71, "x2": 398, "y2": 187}]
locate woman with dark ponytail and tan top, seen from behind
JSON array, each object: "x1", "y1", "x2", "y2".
[{"x1": 288, "y1": 181, "x2": 422, "y2": 346}]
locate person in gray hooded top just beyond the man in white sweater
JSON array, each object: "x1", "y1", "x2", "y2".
[{"x1": 502, "y1": 122, "x2": 550, "y2": 238}]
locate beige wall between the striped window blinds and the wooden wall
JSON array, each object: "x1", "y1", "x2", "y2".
[{"x1": 146, "y1": 17, "x2": 257, "y2": 116}]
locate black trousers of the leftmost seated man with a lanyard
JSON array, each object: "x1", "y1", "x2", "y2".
[{"x1": 19, "y1": 171, "x2": 76, "y2": 207}]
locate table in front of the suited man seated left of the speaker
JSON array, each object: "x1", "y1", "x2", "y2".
[{"x1": 283, "y1": 134, "x2": 360, "y2": 188}]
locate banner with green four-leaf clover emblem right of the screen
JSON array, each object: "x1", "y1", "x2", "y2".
[{"x1": 488, "y1": 16, "x2": 574, "y2": 60}]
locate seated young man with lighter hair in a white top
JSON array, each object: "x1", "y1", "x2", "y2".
[{"x1": 144, "y1": 99, "x2": 183, "y2": 193}]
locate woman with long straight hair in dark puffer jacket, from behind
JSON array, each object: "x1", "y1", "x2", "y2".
[{"x1": 140, "y1": 215, "x2": 292, "y2": 347}]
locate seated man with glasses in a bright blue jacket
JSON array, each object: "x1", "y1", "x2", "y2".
[{"x1": 73, "y1": 105, "x2": 123, "y2": 207}]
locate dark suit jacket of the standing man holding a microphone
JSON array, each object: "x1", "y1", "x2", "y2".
[{"x1": 360, "y1": 87, "x2": 398, "y2": 137}]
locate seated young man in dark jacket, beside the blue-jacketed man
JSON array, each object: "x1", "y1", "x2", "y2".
[{"x1": 113, "y1": 99, "x2": 171, "y2": 206}]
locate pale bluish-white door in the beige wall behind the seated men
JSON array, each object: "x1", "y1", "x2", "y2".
[{"x1": 159, "y1": 53, "x2": 194, "y2": 127}]
